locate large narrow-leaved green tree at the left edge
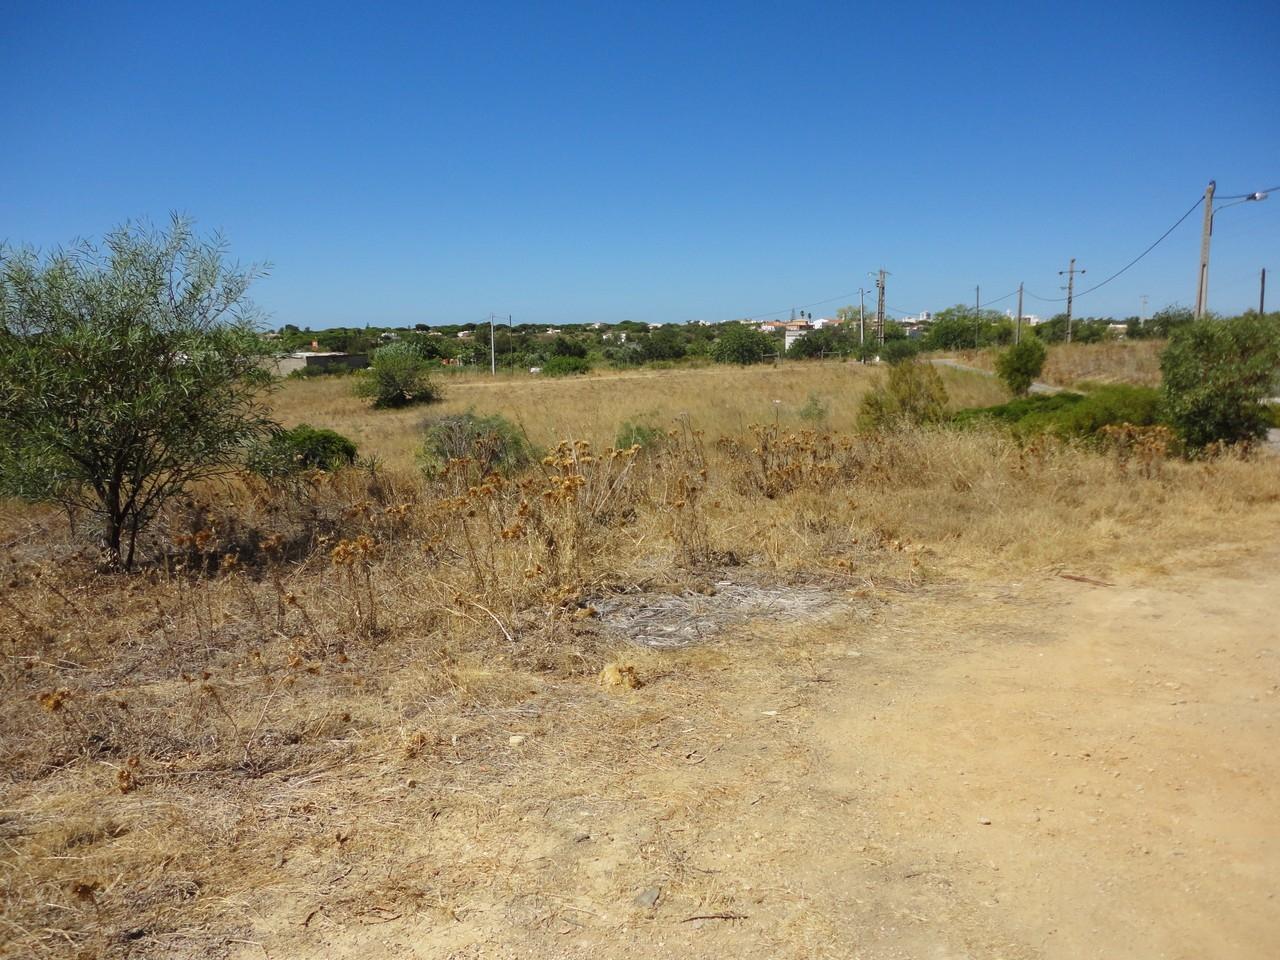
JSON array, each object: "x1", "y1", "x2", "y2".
[{"x1": 0, "y1": 216, "x2": 271, "y2": 570}]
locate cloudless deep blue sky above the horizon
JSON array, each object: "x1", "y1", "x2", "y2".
[{"x1": 0, "y1": 0, "x2": 1280, "y2": 328}]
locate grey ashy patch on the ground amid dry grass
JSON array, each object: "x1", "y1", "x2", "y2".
[{"x1": 591, "y1": 579, "x2": 842, "y2": 649}]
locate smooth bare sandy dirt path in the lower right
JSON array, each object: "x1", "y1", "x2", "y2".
[{"x1": 817, "y1": 554, "x2": 1280, "y2": 960}]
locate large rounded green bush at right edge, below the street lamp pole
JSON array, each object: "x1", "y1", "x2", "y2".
[{"x1": 1160, "y1": 315, "x2": 1280, "y2": 451}]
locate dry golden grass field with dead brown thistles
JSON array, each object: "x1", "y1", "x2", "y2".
[{"x1": 0, "y1": 364, "x2": 1280, "y2": 957}]
